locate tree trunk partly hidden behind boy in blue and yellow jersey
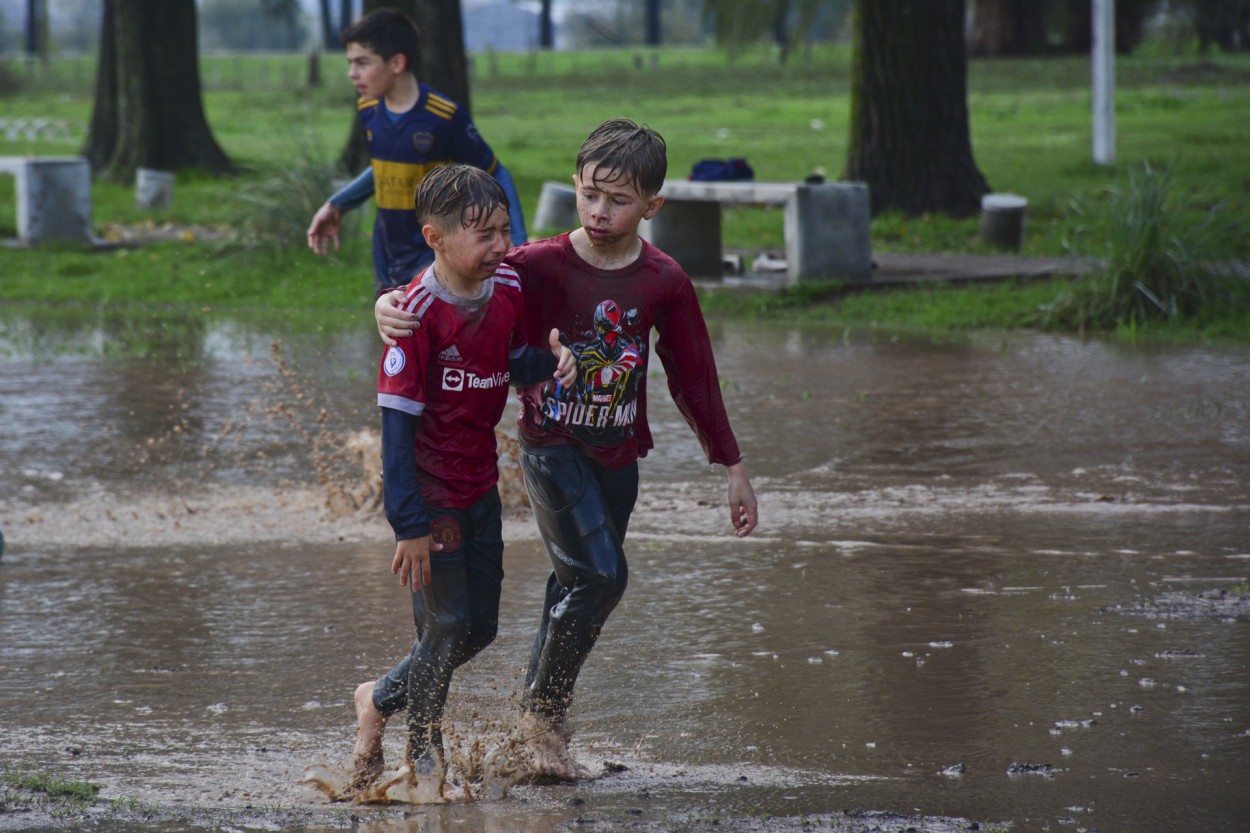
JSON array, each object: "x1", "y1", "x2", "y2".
[{"x1": 339, "y1": 0, "x2": 469, "y2": 173}]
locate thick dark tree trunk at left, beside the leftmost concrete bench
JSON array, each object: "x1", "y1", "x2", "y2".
[{"x1": 83, "y1": 0, "x2": 234, "y2": 180}]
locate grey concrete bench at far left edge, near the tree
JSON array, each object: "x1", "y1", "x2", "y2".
[{"x1": 0, "y1": 156, "x2": 95, "y2": 245}]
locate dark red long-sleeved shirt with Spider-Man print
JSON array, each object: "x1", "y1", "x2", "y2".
[{"x1": 506, "y1": 234, "x2": 743, "y2": 468}]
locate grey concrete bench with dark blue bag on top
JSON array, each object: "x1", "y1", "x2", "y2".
[{"x1": 641, "y1": 179, "x2": 873, "y2": 283}]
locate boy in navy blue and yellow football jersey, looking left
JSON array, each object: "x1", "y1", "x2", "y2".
[{"x1": 308, "y1": 9, "x2": 525, "y2": 293}]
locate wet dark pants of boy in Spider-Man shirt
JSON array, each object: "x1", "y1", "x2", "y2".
[{"x1": 520, "y1": 445, "x2": 638, "y2": 722}]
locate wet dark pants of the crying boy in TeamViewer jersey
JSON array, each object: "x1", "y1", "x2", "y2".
[{"x1": 374, "y1": 489, "x2": 504, "y2": 758}]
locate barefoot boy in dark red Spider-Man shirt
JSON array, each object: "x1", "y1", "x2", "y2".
[{"x1": 374, "y1": 119, "x2": 758, "y2": 779}]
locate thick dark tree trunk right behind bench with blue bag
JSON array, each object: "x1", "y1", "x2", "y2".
[{"x1": 845, "y1": 0, "x2": 990, "y2": 216}]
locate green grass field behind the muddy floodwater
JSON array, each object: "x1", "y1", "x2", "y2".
[{"x1": 0, "y1": 46, "x2": 1250, "y2": 340}]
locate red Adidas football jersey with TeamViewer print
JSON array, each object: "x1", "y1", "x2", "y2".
[{"x1": 378, "y1": 264, "x2": 525, "y2": 508}]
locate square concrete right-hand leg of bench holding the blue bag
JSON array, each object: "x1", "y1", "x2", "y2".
[{"x1": 785, "y1": 183, "x2": 873, "y2": 283}]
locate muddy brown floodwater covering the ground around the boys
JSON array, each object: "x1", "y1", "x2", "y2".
[{"x1": 0, "y1": 311, "x2": 1250, "y2": 833}]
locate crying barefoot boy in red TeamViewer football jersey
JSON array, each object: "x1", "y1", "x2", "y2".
[{"x1": 354, "y1": 165, "x2": 574, "y2": 803}]
